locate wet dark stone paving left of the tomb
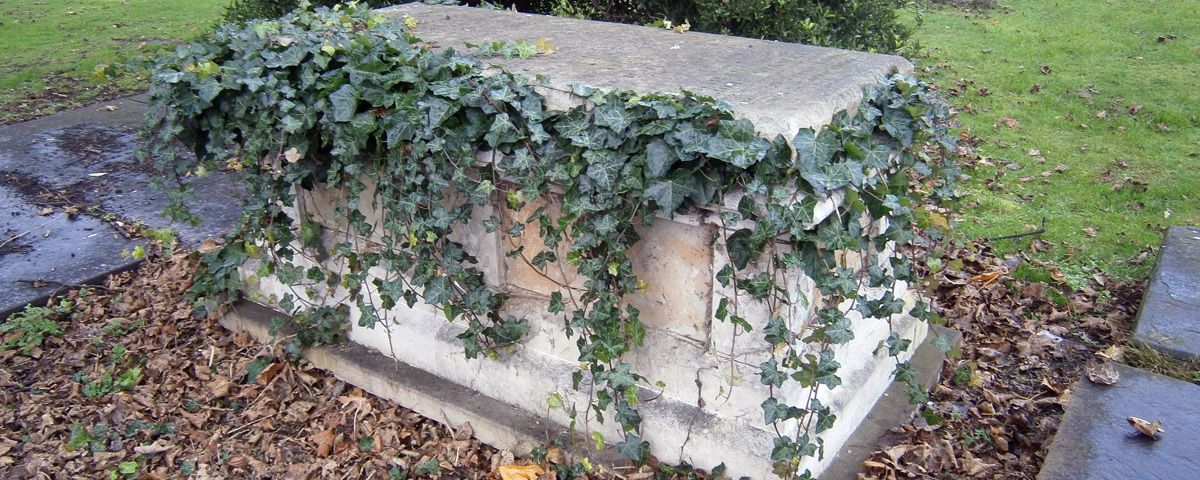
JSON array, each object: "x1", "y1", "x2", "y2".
[{"x1": 0, "y1": 97, "x2": 244, "y2": 318}]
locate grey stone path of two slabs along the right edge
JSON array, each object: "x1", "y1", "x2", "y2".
[{"x1": 1038, "y1": 227, "x2": 1200, "y2": 480}]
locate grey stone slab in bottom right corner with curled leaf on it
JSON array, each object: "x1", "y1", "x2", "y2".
[{"x1": 1038, "y1": 365, "x2": 1200, "y2": 480}]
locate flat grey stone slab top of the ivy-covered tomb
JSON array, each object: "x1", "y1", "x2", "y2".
[{"x1": 379, "y1": 4, "x2": 912, "y2": 139}]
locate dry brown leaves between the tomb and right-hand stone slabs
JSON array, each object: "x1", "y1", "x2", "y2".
[{"x1": 860, "y1": 237, "x2": 1141, "y2": 479}]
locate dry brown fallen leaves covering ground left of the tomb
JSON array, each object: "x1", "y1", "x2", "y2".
[{"x1": 0, "y1": 253, "x2": 512, "y2": 479}]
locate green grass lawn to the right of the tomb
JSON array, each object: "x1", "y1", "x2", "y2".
[{"x1": 914, "y1": 0, "x2": 1200, "y2": 280}]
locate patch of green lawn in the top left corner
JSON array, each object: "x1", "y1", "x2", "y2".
[{"x1": 0, "y1": 0, "x2": 229, "y2": 122}]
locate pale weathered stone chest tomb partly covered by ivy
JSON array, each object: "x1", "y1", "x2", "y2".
[{"x1": 227, "y1": 4, "x2": 926, "y2": 478}]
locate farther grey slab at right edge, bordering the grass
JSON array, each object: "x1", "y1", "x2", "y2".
[{"x1": 1133, "y1": 227, "x2": 1200, "y2": 362}]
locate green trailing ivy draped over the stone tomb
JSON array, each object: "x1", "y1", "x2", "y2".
[{"x1": 146, "y1": 6, "x2": 954, "y2": 476}]
